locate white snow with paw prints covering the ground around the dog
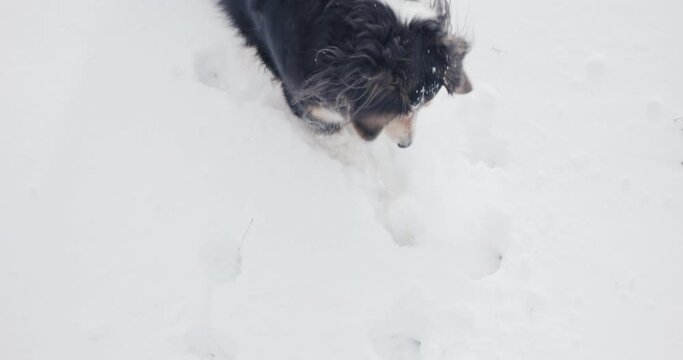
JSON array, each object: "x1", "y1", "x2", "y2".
[{"x1": 0, "y1": 0, "x2": 683, "y2": 360}]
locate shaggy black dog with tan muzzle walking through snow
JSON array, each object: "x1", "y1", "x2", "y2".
[{"x1": 219, "y1": 0, "x2": 472, "y2": 147}]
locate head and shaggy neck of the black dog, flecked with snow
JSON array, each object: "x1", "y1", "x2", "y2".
[{"x1": 294, "y1": 0, "x2": 472, "y2": 147}]
